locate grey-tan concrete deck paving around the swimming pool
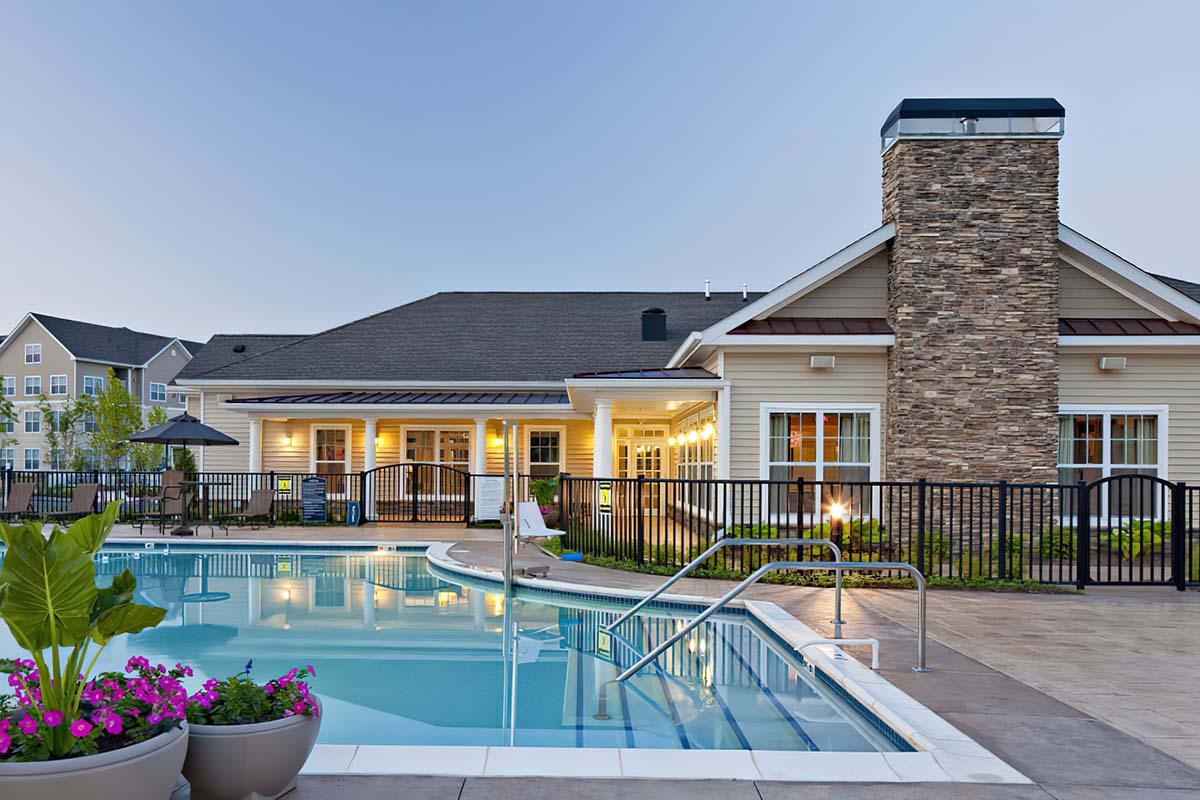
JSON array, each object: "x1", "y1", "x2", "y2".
[{"x1": 105, "y1": 527, "x2": 1200, "y2": 800}]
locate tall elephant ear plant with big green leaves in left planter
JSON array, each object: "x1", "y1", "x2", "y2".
[{"x1": 0, "y1": 503, "x2": 166, "y2": 758}]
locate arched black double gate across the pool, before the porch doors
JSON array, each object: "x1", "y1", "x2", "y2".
[{"x1": 362, "y1": 462, "x2": 472, "y2": 523}]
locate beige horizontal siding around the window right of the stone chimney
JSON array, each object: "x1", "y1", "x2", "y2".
[{"x1": 1058, "y1": 351, "x2": 1200, "y2": 483}]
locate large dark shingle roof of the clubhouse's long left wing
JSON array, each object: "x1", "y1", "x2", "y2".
[{"x1": 179, "y1": 291, "x2": 761, "y2": 381}]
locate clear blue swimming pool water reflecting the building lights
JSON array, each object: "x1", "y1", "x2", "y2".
[{"x1": 0, "y1": 545, "x2": 907, "y2": 752}]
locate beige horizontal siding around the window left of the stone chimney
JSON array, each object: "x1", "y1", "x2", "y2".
[{"x1": 725, "y1": 350, "x2": 887, "y2": 479}]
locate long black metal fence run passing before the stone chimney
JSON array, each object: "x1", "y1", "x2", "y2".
[{"x1": 560, "y1": 474, "x2": 1200, "y2": 588}]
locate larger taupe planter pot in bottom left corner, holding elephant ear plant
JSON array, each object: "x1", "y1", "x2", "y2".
[{"x1": 0, "y1": 724, "x2": 188, "y2": 800}]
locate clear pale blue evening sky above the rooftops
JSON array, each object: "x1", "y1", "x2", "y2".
[{"x1": 0, "y1": 0, "x2": 1200, "y2": 338}]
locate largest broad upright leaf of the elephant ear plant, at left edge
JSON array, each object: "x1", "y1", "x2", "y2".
[{"x1": 0, "y1": 525, "x2": 96, "y2": 650}]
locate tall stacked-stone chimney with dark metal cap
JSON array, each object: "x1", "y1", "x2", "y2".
[{"x1": 881, "y1": 100, "x2": 1066, "y2": 482}]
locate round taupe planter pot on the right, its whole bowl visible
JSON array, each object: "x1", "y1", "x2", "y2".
[{"x1": 184, "y1": 694, "x2": 323, "y2": 800}]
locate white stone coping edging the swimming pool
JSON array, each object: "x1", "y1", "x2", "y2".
[{"x1": 109, "y1": 537, "x2": 1032, "y2": 784}]
